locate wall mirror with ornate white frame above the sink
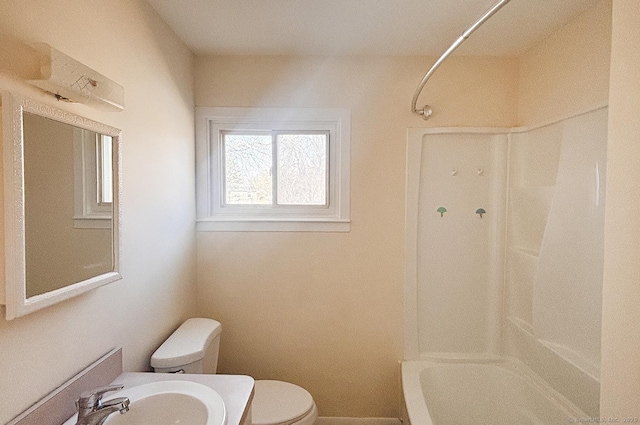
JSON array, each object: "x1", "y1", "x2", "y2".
[{"x1": 2, "y1": 93, "x2": 121, "y2": 319}]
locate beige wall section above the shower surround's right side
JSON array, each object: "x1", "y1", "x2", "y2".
[{"x1": 518, "y1": 0, "x2": 611, "y2": 126}]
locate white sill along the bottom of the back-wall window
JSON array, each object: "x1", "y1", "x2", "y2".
[{"x1": 196, "y1": 218, "x2": 351, "y2": 233}]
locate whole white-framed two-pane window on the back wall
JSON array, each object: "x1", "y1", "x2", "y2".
[{"x1": 196, "y1": 108, "x2": 350, "y2": 232}]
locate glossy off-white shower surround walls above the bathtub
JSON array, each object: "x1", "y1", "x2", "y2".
[{"x1": 405, "y1": 107, "x2": 607, "y2": 418}]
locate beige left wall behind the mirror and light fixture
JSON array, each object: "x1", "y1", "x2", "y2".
[{"x1": 0, "y1": 0, "x2": 195, "y2": 423}]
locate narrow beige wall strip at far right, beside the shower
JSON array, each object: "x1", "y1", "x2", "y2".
[{"x1": 601, "y1": 0, "x2": 640, "y2": 421}]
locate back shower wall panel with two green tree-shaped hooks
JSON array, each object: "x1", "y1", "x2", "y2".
[{"x1": 417, "y1": 133, "x2": 507, "y2": 353}]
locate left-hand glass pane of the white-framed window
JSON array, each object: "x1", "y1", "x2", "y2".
[{"x1": 224, "y1": 134, "x2": 272, "y2": 205}]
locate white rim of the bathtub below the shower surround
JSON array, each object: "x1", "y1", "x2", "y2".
[{"x1": 400, "y1": 353, "x2": 588, "y2": 425}]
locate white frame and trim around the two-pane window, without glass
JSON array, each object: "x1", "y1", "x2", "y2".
[{"x1": 196, "y1": 107, "x2": 351, "y2": 232}]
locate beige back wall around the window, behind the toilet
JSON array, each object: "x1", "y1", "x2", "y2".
[{"x1": 195, "y1": 57, "x2": 517, "y2": 417}]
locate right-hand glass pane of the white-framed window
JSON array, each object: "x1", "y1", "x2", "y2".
[{"x1": 277, "y1": 134, "x2": 328, "y2": 205}]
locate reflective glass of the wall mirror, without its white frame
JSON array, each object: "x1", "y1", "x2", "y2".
[{"x1": 23, "y1": 112, "x2": 114, "y2": 298}]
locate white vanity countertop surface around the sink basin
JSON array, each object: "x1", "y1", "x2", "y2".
[{"x1": 113, "y1": 372, "x2": 254, "y2": 425}]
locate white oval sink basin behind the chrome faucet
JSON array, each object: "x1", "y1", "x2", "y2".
[{"x1": 63, "y1": 381, "x2": 227, "y2": 425}]
